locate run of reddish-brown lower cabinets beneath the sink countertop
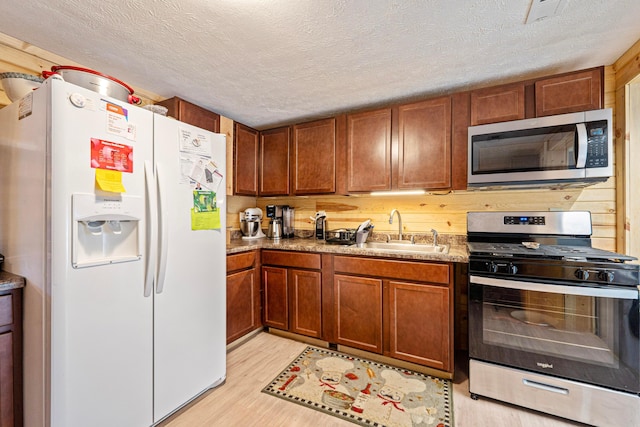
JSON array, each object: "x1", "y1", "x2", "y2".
[{"x1": 227, "y1": 249, "x2": 454, "y2": 373}]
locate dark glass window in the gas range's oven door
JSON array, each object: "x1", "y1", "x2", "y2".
[{"x1": 482, "y1": 287, "x2": 624, "y2": 368}]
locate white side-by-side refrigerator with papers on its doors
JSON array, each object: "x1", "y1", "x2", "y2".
[{"x1": 0, "y1": 79, "x2": 226, "y2": 427}]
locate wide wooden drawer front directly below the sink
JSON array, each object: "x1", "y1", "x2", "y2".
[{"x1": 333, "y1": 256, "x2": 450, "y2": 285}]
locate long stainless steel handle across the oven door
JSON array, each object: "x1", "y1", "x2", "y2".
[{"x1": 469, "y1": 275, "x2": 639, "y2": 299}]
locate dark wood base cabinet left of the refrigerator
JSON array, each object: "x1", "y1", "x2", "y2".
[{"x1": 0, "y1": 288, "x2": 23, "y2": 427}]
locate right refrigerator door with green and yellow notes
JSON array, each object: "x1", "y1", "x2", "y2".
[{"x1": 154, "y1": 115, "x2": 226, "y2": 422}]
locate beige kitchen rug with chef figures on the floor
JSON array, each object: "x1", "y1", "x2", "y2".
[{"x1": 262, "y1": 347, "x2": 453, "y2": 427}]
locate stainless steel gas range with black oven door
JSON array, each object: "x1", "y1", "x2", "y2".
[{"x1": 467, "y1": 211, "x2": 640, "y2": 426}]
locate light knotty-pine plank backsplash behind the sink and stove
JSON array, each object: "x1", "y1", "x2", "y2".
[{"x1": 227, "y1": 178, "x2": 615, "y2": 250}]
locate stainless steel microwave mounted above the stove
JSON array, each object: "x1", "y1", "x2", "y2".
[{"x1": 467, "y1": 108, "x2": 613, "y2": 188}]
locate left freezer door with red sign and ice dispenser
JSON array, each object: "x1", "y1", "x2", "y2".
[{"x1": 47, "y1": 81, "x2": 153, "y2": 427}]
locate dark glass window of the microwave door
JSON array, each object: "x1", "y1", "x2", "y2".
[{"x1": 471, "y1": 125, "x2": 576, "y2": 175}]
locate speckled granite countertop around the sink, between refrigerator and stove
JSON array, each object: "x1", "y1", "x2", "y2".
[{"x1": 227, "y1": 236, "x2": 469, "y2": 263}]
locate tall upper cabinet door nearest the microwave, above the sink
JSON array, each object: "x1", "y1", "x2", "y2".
[{"x1": 397, "y1": 96, "x2": 451, "y2": 189}]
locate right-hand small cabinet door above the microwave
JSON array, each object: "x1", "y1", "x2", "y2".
[{"x1": 535, "y1": 67, "x2": 604, "y2": 117}]
